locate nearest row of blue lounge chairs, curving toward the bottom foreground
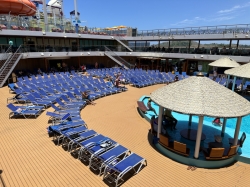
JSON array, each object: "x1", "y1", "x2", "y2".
[{"x1": 47, "y1": 102, "x2": 147, "y2": 186}]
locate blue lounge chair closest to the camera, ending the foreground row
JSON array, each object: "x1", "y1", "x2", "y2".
[{"x1": 103, "y1": 153, "x2": 147, "y2": 186}]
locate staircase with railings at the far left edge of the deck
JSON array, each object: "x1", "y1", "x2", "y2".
[{"x1": 0, "y1": 45, "x2": 22, "y2": 88}]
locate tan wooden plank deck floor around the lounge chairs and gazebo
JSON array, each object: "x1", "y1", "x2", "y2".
[{"x1": 0, "y1": 85, "x2": 250, "y2": 187}]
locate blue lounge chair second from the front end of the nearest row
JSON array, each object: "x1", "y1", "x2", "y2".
[{"x1": 89, "y1": 145, "x2": 129, "y2": 175}]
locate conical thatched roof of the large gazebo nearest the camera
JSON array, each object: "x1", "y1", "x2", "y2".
[{"x1": 151, "y1": 76, "x2": 250, "y2": 118}]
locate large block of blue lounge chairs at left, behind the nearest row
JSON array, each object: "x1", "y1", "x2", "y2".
[{"x1": 7, "y1": 72, "x2": 127, "y2": 117}]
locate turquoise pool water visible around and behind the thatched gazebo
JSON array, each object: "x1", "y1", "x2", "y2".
[{"x1": 140, "y1": 96, "x2": 250, "y2": 158}]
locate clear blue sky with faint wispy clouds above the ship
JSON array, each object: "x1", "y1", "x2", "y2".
[{"x1": 47, "y1": 0, "x2": 250, "y2": 30}]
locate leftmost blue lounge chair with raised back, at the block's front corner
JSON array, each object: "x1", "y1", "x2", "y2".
[{"x1": 7, "y1": 103, "x2": 42, "y2": 119}]
